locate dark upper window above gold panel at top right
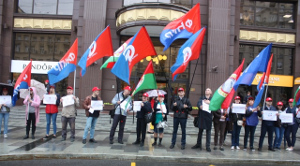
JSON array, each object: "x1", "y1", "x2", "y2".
[{"x1": 240, "y1": 0, "x2": 295, "y2": 29}]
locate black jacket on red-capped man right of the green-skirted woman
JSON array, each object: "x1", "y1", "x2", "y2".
[{"x1": 171, "y1": 96, "x2": 192, "y2": 119}]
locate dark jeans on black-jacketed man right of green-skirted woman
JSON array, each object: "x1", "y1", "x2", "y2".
[{"x1": 172, "y1": 118, "x2": 187, "y2": 145}]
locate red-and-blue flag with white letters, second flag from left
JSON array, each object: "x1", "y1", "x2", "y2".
[{"x1": 48, "y1": 39, "x2": 78, "y2": 85}]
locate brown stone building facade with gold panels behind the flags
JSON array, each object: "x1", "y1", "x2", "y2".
[{"x1": 0, "y1": 0, "x2": 300, "y2": 106}]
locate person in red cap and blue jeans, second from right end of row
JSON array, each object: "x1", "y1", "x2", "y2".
[{"x1": 273, "y1": 101, "x2": 287, "y2": 149}]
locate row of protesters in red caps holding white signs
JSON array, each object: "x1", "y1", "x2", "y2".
[{"x1": 0, "y1": 85, "x2": 300, "y2": 152}]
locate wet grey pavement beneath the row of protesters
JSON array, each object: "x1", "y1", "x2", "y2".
[{"x1": 0, "y1": 106, "x2": 300, "y2": 166}]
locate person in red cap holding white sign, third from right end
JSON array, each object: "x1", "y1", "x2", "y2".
[{"x1": 258, "y1": 97, "x2": 277, "y2": 152}]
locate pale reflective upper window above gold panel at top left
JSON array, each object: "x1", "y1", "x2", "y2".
[{"x1": 17, "y1": 0, "x2": 73, "y2": 15}]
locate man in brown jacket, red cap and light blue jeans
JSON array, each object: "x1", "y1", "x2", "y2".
[{"x1": 82, "y1": 87, "x2": 101, "y2": 144}]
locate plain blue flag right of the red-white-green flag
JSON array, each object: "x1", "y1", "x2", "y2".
[{"x1": 233, "y1": 43, "x2": 272, "y2": 90}]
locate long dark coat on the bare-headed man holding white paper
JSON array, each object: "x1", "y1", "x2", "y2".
[{"x1": 197, "y1": 96, "x2": 212, "y2": 130}]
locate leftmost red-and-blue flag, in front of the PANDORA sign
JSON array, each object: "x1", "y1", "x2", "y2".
[{"x1": 12, "y1": 60, "x2": 32, "y2": 106}]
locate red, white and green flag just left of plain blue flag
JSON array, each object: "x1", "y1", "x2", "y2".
[{"x1": 209, "y1": 59, "x2": 245, "y2": 111}]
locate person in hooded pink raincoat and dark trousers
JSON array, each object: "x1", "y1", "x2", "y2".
[{"x1": 23, "y1": 87, "x2": 41, "y2": 139}]
